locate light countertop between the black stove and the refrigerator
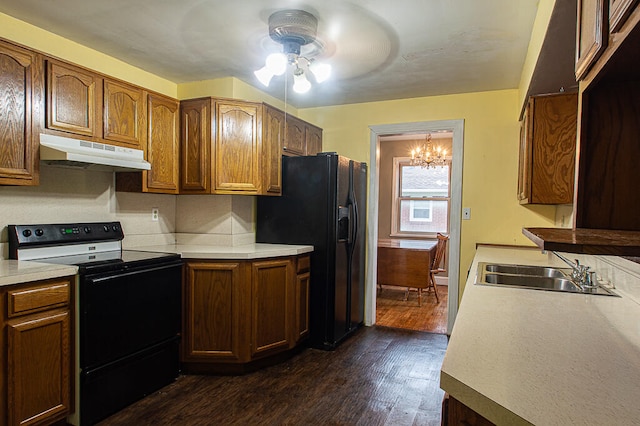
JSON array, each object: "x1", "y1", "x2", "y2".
[{"x1": 130, "y1": 243, "x2": 313, "y2": 260}]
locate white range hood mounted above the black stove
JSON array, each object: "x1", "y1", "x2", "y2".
[{"x1": 40, "y1": 133, "x2": 151, "y2": 172}]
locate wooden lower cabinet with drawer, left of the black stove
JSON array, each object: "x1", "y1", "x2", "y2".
[{"x1": 0, "y1": 277, "x2": 73, "y2": 425}]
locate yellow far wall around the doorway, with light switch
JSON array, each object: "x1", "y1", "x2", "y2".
[{"x1": 300, "y1": 89, "x2": 555, "y2": 294}]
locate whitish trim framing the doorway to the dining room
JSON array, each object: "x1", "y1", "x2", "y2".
[{"x1": 364, "y1": 119, "x2": 464, "y2": 334}]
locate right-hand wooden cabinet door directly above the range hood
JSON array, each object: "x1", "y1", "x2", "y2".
[{"x1": 104, "y1": 79, "x2": 146, "y2": 149}]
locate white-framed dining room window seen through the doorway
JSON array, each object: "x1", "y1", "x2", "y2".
[{"x1": 391, "y1": 157, "x2": 451, "y2": 236}]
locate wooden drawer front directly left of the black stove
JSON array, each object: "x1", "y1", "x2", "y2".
[{"x1": 7, "y1": 279, "x2": 71, "y2": 317}]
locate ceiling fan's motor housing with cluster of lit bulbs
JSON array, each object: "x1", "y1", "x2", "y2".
[{"x1": 254, "y1": 9, "x2": 331, "y2": 93}]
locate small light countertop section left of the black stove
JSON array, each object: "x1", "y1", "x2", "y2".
[{"x1": 0, "y1": 260, "x2": 78, "y2": 286}]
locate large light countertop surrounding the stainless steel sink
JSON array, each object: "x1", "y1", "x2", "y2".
[{"x1": 440, "y1": 246, "x2": 640, "y2": 425}]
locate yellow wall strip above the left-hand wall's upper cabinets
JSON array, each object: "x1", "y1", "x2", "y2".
[{"x1": 0, "y1": 13, "x2": 178, "y2": 98}]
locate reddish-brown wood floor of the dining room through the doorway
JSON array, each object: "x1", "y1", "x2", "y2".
[{"x1": 376, "y1": 285, "x2": 449, "y2": 334}]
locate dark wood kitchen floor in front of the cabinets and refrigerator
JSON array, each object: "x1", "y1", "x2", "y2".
[{"x1": 100, "y1": 326, "x2": 447, "y2": 426}]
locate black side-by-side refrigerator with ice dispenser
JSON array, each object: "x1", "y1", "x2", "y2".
[{"x1": 256, "y1": 153, "x2": 367, "y2": 350}]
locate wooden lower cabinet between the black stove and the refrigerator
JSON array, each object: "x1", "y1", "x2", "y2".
[{"x1": 182, "y1": 256, "x2": 309, "y2": 373}]
